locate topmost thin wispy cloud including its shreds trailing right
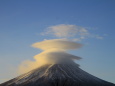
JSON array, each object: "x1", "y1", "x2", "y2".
[{"x1": 42, "y1": 24, "x2": 104, "y2": 41}]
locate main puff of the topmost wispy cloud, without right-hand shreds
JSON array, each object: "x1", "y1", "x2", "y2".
[{"x1": 42, "y1": 24, "x2": 89, "y2": 38}]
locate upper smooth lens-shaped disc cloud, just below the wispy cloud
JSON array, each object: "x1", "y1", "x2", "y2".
[{"x1": 32, "y1": 39, "x2": 82, "y2": 50}]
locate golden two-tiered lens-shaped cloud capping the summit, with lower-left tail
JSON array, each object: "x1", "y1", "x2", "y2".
[{"x1": 19, "y1": 39, "x2": 82, "y2": 74}]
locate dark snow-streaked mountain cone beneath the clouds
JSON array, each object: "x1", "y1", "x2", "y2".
[{"x1": 0, "y1": 60, "x2": 115, "y2": 86}]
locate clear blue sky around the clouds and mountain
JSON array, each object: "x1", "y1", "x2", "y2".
[{"x1": 0, "y1": 0, "x2": 115, "y2": 83}]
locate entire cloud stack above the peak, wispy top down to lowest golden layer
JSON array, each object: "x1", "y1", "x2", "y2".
[{"x1": 19, "y1": 24, "x2": 102, "y2": 73}]
